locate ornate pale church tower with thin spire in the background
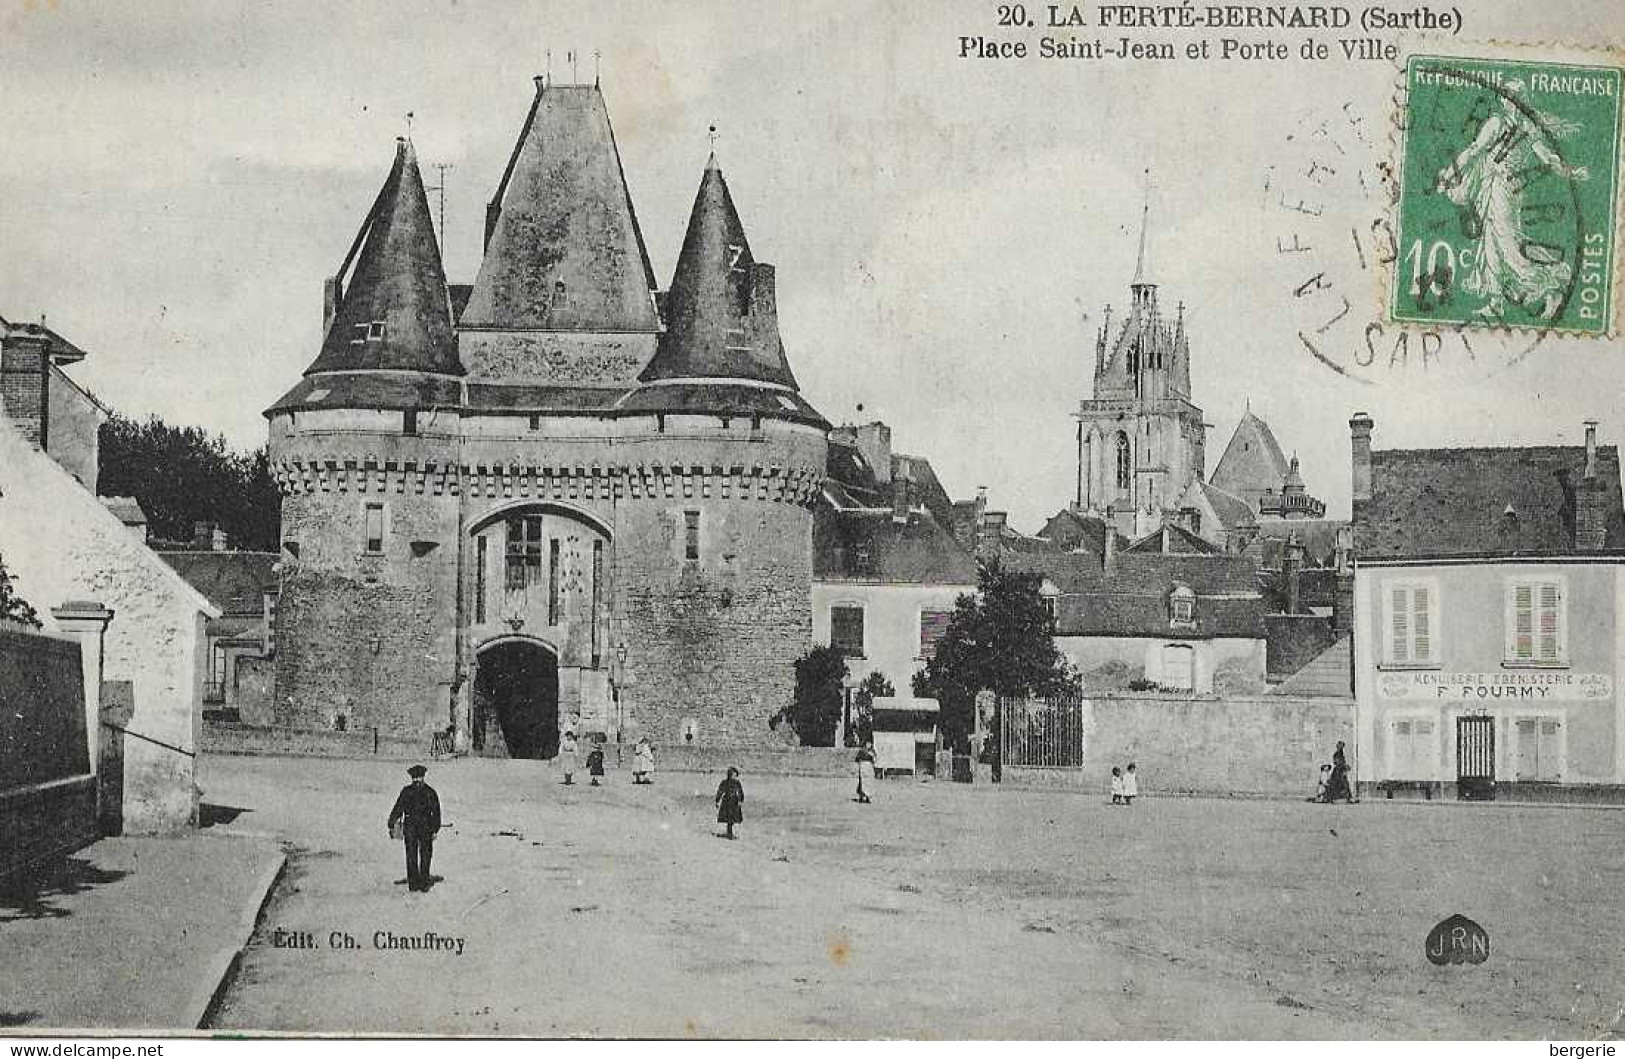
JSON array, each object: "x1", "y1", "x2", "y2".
[{"x1": 1074, "y1": 180, "x2": 1204, "y2": 538}]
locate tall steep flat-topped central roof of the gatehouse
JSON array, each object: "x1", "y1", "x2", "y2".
[{"x1": 458, "y1": 78, "x2": 660, "y2": 331}]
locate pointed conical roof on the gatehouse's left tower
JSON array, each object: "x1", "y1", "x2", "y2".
[{"x1": 306, "y1": 140, "x2": 463, "y2": 375}]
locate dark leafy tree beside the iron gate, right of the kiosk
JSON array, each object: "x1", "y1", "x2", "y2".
[{"x1": 917, "y1": 559, "x2": 1081, "y2": 747}]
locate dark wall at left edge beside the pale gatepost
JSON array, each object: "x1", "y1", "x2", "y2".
[{"x1": 0, "y1": 627, "x2": 98, "y2": 877}]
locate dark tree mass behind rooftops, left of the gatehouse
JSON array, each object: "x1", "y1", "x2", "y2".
[{"x1": 96, "y1": 414, "x2": 281, "y2": 551}]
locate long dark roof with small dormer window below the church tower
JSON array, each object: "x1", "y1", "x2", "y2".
[{"x1": 1004, "y1": 552, "x2": 1266, "y2": 640}]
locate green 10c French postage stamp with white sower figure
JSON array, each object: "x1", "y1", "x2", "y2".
[{"x1": 1389, "y1": 55, "x2": 1622, "y2": 335}]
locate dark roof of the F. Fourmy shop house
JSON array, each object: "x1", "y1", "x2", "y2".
[{"x1": 1355, "y1": 445, "x2": 1625, "y2": 559}]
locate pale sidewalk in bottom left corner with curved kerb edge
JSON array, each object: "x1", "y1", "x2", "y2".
[{"x1": 0, "y1": 832, "x2": 283, "y2": 1033}]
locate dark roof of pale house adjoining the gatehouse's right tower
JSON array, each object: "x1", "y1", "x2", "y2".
[{"x1": 813, "y1": 505, "x2": 978, "y2": 590}]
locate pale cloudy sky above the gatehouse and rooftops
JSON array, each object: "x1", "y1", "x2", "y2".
[{"x1": 0, "y1": 0, "x2": 1625, "y2": 531}]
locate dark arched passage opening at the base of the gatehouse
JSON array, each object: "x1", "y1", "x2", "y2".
[{"x1": 473, "y1": 638, "x2": 559, "y2": 759}]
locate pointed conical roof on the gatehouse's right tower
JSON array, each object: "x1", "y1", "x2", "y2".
[{"x1": 639, "y1": 154, "x2": 796, "y2": 390}]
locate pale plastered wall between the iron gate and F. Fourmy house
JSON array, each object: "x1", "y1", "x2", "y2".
[{"x1": 1003, "y1": 695, "x2": 1354, "y2": 797}]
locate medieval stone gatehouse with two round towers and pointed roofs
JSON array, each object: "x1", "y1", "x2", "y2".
[{"x1": 267, "y1": 78, "x2": 829, "y2": 757}]
